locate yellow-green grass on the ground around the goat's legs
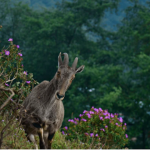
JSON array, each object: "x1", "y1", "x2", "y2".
[{"x1": 0, "y1": 116, "x2": 91, "y2": 149}]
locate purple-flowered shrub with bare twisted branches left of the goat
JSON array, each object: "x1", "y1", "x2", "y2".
[{"x1": 0, "y1": 34, "x2": 38, "y2": 148}]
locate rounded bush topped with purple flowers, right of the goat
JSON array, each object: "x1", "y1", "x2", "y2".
[{"x1": 62, "y1": 107, "x2": 128, "y2": 149}]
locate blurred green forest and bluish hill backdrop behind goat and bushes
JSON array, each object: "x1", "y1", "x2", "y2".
[{"x1": 0, "y1": 0, "x2": 150, "y2": 149}]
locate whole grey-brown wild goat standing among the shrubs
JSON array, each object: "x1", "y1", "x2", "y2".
[{"x1": 20, "y1": 53, "x2": 84, "y2": 149}]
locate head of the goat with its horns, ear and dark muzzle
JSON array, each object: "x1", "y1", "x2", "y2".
[{"x1": 54, "y1": 53, "x2": 84, "y2": 100}]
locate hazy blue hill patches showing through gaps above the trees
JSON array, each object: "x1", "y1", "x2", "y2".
[{"x1": 11, "y1": 0, "x2": 148, "y2": 31}]
